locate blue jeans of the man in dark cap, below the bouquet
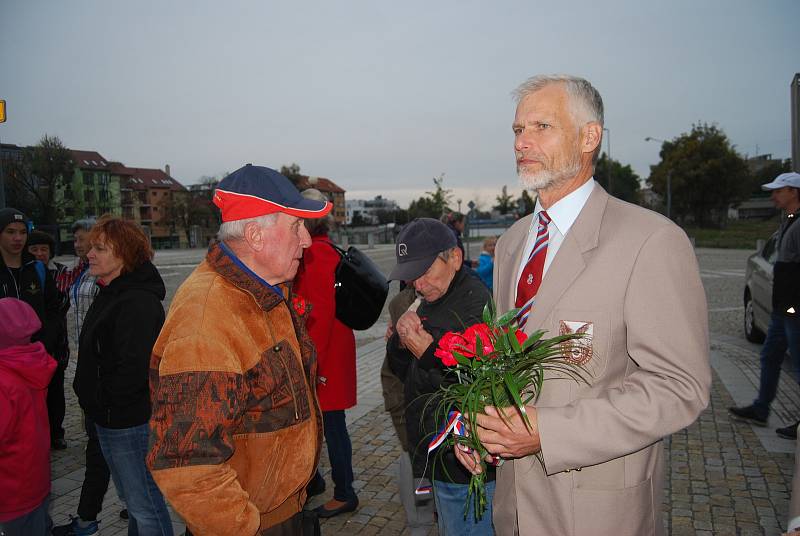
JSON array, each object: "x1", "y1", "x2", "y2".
[{"x1": 433, "y1": 480, "x2": 495, "y2": 536}]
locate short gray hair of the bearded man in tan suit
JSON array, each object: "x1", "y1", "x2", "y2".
[{"x1": 512, "y1": 74, "x2": 603, "y2": 128}]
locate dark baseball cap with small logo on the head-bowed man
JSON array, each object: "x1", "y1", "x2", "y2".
[{"x1": 389, "y1": 218, "x2": 457, "y2": 281}]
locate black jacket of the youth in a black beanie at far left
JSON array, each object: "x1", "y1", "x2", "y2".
[{"x1": 0, "y1": 251, "x2": 61, "y2": 355}]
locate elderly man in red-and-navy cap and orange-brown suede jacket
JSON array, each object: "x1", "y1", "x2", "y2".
[{"x1": 147, "y1": 164, "x2": 332, "y2": 536}]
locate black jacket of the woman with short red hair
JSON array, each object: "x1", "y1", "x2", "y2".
[{"x1": 72, "y1": 262, "x2": 166, "y2": 428}]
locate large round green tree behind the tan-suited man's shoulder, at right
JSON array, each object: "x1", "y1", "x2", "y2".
[{"x1": 648, "y1": 123, "x2": 751, "y2": 227}]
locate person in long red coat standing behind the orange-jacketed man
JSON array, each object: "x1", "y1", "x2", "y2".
[{"x1": 294, "y1": 188, "x2": 358, "y2": 517}]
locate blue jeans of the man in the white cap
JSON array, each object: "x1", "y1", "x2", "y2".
[{"x1": 753, "y1": 313, "x2": 800, "y2": 418}]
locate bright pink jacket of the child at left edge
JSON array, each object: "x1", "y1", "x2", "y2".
[{"x1": 0, "y1": 320, "x2": 56, "y2": 522}]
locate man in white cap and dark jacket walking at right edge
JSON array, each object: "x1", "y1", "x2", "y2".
[{"x1": 728, "y1": 173, "x2": 800, "y2": 439}]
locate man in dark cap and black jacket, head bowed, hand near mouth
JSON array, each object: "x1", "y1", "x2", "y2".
[{"x1": 387, "y1": 218, "x2": 494, "y2": 535}]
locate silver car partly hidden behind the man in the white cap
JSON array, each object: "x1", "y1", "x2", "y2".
[{"x1": 744, "y1": 233, "x2": 778, "y2": 343}]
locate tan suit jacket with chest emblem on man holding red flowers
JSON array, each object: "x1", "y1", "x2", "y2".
[{"x1": 493, "y1": 185, "x2": 711, "y2": 536}]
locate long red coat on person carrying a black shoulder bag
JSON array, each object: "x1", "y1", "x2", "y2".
[{"x1": 294, "y1": 235, "x2": 356, "y2": 411}]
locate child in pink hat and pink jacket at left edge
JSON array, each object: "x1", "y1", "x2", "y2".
[{"x1": 0, "y1": 298, "x2": 57, "y2": 536}]
